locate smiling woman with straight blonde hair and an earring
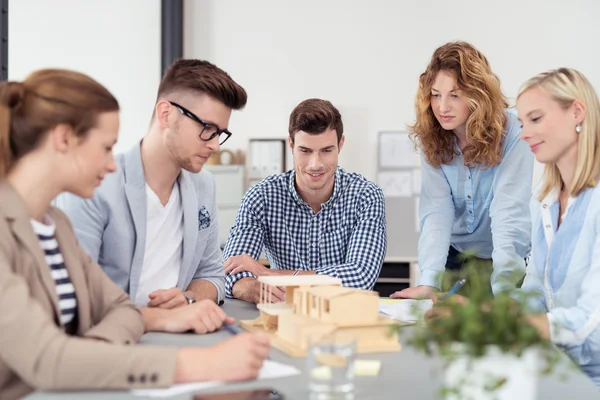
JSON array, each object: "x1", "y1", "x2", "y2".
[{"x1": 517, "y1": 68, "x2": 600, "y2": 386}]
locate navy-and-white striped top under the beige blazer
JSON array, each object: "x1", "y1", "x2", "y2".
[{"x1": 31, "y1": 217, "x2": 77, "y2": 330}]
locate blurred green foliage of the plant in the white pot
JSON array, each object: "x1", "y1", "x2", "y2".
[{"x1": 400, "y1": 251, "x2": 561, "y2": 391}]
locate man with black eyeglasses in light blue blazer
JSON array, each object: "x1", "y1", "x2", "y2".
[{"x1": 56, "y1": 60, "x2": 247, "y2": 333}]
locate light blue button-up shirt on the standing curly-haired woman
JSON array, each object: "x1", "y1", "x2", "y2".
[{"x1": 419, "y1": 110, "x2": 533, "y2": 293}]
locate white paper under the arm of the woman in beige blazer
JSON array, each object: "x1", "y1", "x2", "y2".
[{"x1": 131, "y1": 360, "x2": 300, "y2": 397}]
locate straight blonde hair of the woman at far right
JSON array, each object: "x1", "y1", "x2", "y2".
[{"x1": 517, "y1": 68, "x2": 600, "y2": 201}]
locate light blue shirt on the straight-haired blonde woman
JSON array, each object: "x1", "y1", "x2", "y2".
[{"x1": 517, "y1": 187, "x2": 600, "y2": 386}]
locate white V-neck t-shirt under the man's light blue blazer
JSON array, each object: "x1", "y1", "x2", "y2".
[{"x1": 134, "y1": 183, "x2": 183, "y2": 306}]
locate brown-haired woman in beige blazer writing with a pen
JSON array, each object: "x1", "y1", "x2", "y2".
[{"x1": 0, "y1": 70, "x2": 269, "y2": 399}]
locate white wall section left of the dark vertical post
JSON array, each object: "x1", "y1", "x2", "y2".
[{"x1": 8, "y1": 0, "x2": 161, "y2": 152}]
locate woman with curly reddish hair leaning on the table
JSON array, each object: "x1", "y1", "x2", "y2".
[{"x1": 391, "y1": 42, "x2": 533, "y2": 298}]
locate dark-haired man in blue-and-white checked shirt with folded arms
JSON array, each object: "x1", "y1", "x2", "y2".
[{"x1": 223, "y1": 99, "x2": 387, "y2": 303}]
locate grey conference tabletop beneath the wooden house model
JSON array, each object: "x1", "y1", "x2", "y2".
[{"x1": 26, "y1": 300, "x2": 600, "y2": 400}]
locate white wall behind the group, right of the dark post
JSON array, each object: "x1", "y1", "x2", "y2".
[{"x1": 184, "y1": 0, "x2": 600, "y2": 187}]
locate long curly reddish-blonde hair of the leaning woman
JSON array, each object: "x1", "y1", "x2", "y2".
[{"x1": 408, "y1": 42, "x2": 508, "y2": 168}]
